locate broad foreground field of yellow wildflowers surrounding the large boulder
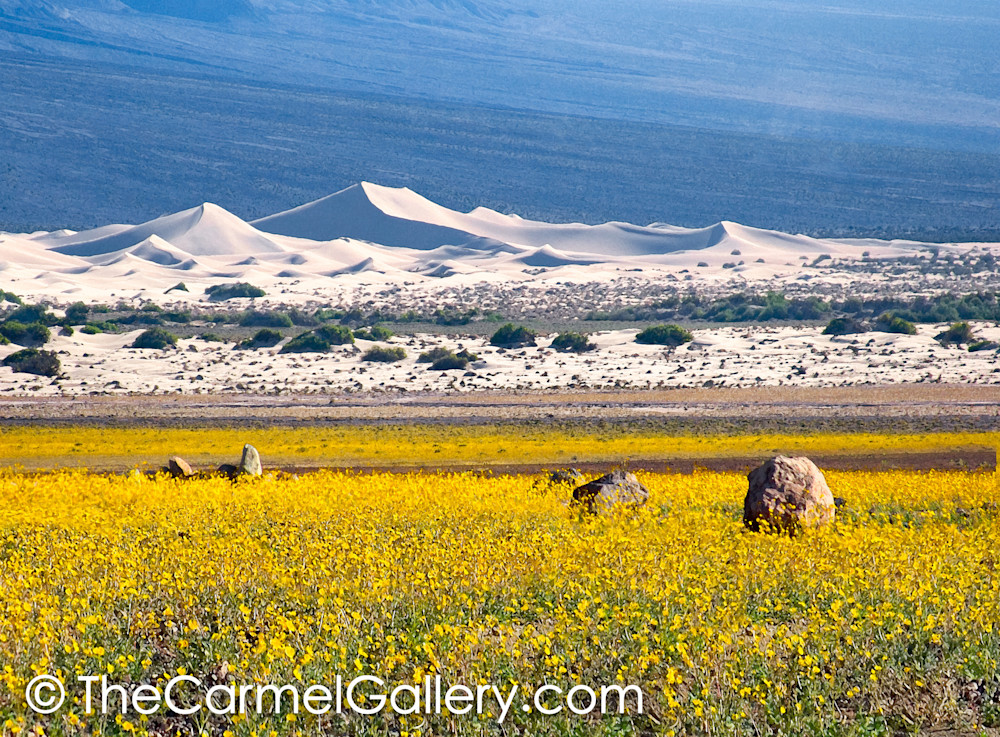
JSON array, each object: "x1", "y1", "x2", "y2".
[{"x1": 0, "y1": 471, "x2": 1000, "y2": 737}]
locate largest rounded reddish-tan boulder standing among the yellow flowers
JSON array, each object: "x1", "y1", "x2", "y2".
[{"x1": 743, "y1": 456, "x2": 836, "y2": 533}]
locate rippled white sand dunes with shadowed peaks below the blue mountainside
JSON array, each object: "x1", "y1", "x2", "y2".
[{"x1": 0, "y1": 182, "x2": 1000, "y2": 308}]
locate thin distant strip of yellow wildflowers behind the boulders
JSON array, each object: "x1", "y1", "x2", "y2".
[{"x1": 0, "y1": 424, "x2": 1000, "y2": 468}]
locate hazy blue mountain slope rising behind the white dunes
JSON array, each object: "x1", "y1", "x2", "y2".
[{"x1": 0, "y1": 0, "x2": 1000, "y2": 240}]
